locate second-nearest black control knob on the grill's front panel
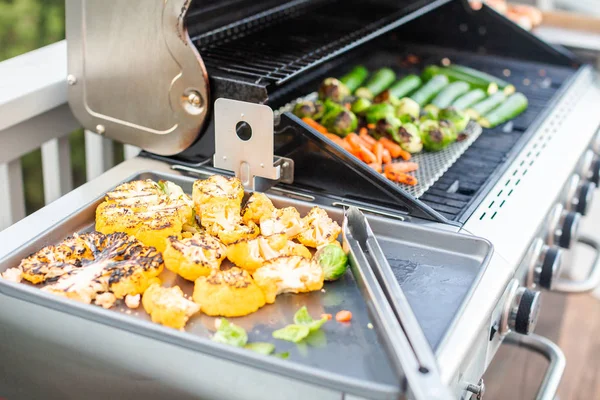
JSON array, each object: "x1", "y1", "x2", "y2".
[{"x1": 527, "y1": 239, "x2": 563, "y2": 290}]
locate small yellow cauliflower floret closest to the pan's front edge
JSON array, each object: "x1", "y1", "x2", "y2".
[{"x1": 142, "y1": 284, "x2": 200, "y2": 329}]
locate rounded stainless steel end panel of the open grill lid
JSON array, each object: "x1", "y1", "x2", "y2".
[{"x1": 66, "y1": 0, "x2": 210, "y2": 155}]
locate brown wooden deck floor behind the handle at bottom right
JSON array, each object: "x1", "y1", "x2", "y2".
[{"x1": 484, "y1": 293, "x2": 600, "y2": 400}]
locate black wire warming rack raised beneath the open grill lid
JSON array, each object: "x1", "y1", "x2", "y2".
[{"x1": 193, "y1": 0, "x2": 440, "y2": 85}]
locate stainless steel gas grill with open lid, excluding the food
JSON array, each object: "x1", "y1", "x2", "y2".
[{"x1": 0, "y1": 0, "x2": 600, "y2": 399}]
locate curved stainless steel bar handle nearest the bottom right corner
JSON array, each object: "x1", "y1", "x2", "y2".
[{"x1": 505, "y1": 333, "x2": 566, "y2": 400}]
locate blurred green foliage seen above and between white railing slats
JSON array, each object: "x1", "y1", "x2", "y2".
[{"x1": 0, "y1": 0, "x2": 123, "y2": 214}]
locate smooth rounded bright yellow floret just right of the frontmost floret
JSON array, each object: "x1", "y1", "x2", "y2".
[{"x1": 193, "y1": 267, "x2": 265, "y2": 317}]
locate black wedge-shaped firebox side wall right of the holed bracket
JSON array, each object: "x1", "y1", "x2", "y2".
[{"x1": 276, "y1": 112, "x2": 449, "y2": 223}]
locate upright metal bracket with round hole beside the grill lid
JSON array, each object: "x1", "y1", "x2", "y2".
[{"x1": 214, "y1": 98, "x2": 294, "y2": 191}]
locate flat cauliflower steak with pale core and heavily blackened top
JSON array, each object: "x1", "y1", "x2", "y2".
[{"x1": 42, "y1": 233, "x2": 163, "y2": 306}]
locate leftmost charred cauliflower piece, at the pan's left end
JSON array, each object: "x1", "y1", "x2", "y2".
[{"x1": 18, "y1": 232, "x2": 104, "y2": 284}]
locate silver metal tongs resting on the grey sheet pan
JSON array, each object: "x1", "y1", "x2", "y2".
[{"x1": 343, "y1": 207, "x2": 453, "y2": 400}]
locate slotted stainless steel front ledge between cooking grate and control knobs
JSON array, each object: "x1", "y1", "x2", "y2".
[{"x1": 448, "y1": 67, "x2": 600, "y2": 387}]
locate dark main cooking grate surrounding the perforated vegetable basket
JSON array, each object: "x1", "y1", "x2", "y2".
[{"x1": 271, "y1": 47, "x2": 576, "y2": 222}]
